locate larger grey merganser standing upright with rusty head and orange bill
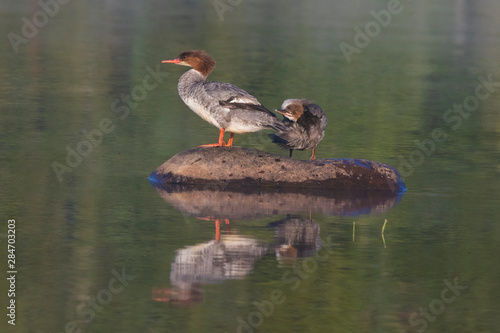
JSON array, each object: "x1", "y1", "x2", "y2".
[{"x1": 162, "y1": 50, "x2": 284, "y2": 147}]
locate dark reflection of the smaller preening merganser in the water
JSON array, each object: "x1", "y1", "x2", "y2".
[{"x1": 270, "y1": 217, "x2": 321, "y2": 261}]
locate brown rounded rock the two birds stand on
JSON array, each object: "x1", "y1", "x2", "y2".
[{"x1": 150, "y1": 147, "x2": 406, "y2": 193}]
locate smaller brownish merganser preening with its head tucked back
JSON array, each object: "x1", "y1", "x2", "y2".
[{"x1": 269, "y1": 99, "x2": 328, "y2": 160}]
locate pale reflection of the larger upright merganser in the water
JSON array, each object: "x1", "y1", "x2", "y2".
[{"x1": 152, "y1": 234, "x2": 268, "y2": 305}]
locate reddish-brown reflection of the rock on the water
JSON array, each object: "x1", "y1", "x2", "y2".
[{"x1": 151, "y1": 186, "x2": 401, "y2": 219}]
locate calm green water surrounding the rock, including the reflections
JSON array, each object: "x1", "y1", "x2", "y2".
[{"x1": 0, "y1": 0, "x2": 500, "y2": 332}]
